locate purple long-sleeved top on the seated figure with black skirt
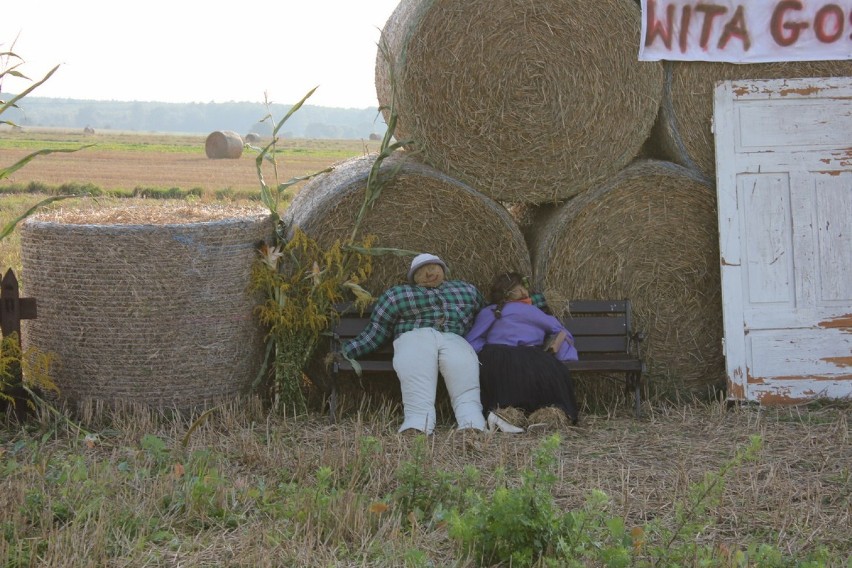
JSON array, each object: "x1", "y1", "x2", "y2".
[{"x1": 465, "y1": 302, "x2": 577, "y2": 361}]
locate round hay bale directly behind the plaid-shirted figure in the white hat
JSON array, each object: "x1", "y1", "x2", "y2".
[{"x1": 285, "y1": 152, "x2": 530, "y2": 296}]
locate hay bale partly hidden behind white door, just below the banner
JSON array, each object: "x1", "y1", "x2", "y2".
[{"x1": 653, "y1": 60, "x2": 852, "y2": 179}]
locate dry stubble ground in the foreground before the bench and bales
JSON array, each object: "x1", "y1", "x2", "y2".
[{"x1": 0, "y1": 403, "x2": 852, "y2": 568}]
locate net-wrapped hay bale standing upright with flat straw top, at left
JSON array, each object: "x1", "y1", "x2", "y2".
[{"x1": 21, "y1": 204, "x2": 273, "y2": 410}]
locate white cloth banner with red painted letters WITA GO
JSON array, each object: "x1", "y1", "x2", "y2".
[{"x1": 639, "y1": 0, "x2": 852, "y2": 63}]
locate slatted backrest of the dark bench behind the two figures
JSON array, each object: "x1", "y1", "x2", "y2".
[{"x1": 332, "y1": 300, "x2": 632, "y2": 359}]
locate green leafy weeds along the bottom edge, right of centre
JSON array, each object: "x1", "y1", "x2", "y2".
[{"x1": 449, "y1": 435, "x2": 844, "y2": 568}]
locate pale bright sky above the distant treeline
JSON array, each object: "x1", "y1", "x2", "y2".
[{"x1": 0, "y1": 0, "x2": 400, "y2": 108}]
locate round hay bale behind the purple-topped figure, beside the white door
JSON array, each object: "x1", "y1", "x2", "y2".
[{"x1": 529, "y1": 160, "x2": 724, "y2": 396}]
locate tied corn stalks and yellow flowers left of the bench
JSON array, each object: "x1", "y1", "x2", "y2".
[{"x1": 249, "y1": 82, "x2": 410, "y2": 413}]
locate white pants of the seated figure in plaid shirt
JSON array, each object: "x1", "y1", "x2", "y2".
[{"x1": 393, "y1": 327, "x2": 485, "y2": 434}]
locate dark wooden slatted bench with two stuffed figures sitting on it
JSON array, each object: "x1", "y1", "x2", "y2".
[{"x1": 329, "y1": 300, "x2": 645, "y2": 418}]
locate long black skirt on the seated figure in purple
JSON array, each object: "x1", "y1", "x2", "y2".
[{"x1": 479, "y1": 345, "x2": 579, "y2": 423}]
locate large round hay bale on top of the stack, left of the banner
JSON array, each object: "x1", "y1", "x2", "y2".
[{"x1": 376, "y1": 0, "x2": 663, "y2": 203}]
